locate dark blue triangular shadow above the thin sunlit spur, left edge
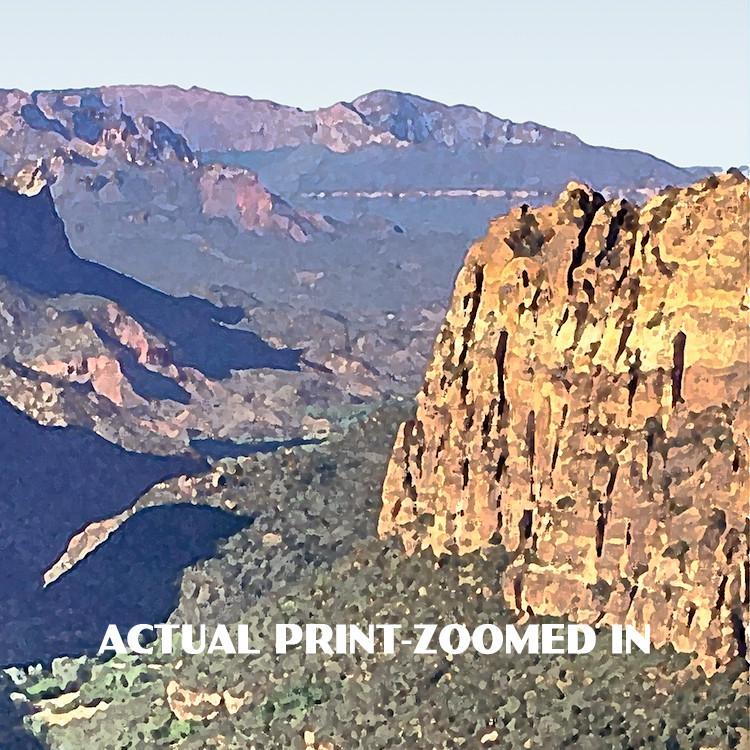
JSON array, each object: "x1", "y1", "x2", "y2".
[{"x1": 0, "y1": 399, "x2": 206, "y2": 588}]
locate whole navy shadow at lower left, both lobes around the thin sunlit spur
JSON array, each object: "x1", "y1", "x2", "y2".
[{"x1": 0, "y1": 399, "x2": 249, "y2": 666}]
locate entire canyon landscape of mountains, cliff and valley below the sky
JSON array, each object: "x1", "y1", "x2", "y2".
[{"x1": 0, "y1": 86, "x2": 748, "y2": 750}]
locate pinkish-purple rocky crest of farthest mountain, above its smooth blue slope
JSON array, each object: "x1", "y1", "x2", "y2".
[{"x1": 89, "y1": 86, "x2": 581, "y2": 152}]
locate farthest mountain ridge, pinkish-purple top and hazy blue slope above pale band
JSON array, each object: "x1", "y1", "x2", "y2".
[{"x1": 82, "y1": 86, "x2": 711, "y2": 201}]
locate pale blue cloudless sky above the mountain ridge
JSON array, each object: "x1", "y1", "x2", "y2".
[{"x1": 0, "y1": 0, "x2": 750, "y2": 167}]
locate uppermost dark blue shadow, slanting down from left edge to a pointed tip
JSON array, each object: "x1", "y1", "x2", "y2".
[{"x1": 0, "y1": 188, "x2": 299, "y2": 378}]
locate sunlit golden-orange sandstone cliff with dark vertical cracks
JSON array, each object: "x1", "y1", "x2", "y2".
[{"x1": 379, "y1": 170, "x2": 750, "y2": 672}]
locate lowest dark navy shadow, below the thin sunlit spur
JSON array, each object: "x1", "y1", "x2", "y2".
[{"x1": 0, "y1": 504, "x2": 252, "y2": 666}]
